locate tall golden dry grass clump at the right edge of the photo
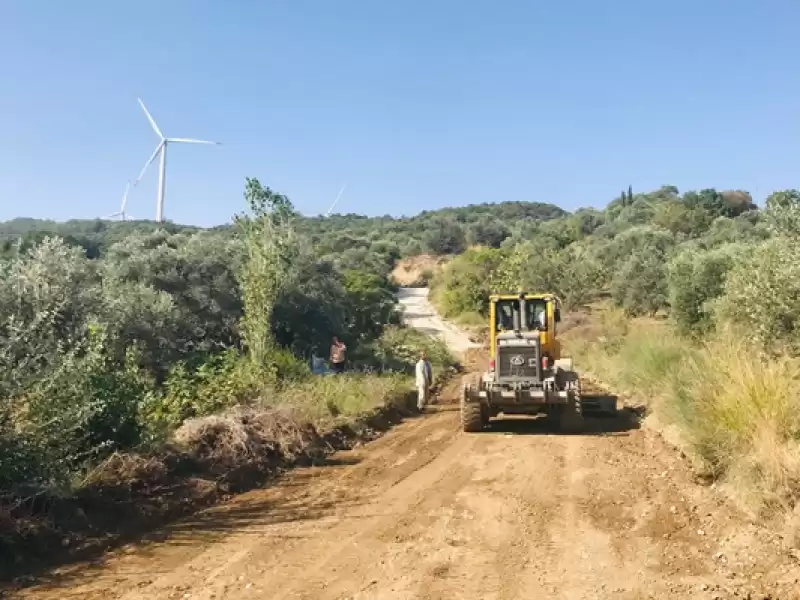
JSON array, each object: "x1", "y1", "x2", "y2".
[{"x1": 670, "y1": 331, "x2": 800, "y2": 510}]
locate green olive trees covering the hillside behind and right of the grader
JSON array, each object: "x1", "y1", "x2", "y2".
[{"x1": 433, "y1": 186, "x2": 800, "y2": 349}]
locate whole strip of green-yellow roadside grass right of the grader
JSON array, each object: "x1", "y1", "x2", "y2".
[{"x1": 565, "y1": 310, "x2": 800, "y2": 522}]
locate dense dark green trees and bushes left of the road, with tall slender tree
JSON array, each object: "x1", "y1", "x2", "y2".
[{"x1": 0, "y1": 179, "x2": 460, "y2": 499}]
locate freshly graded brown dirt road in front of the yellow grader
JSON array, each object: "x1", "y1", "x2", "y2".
[{"x1": 9, "y1": 290, "x2": 800, "y2": 600}]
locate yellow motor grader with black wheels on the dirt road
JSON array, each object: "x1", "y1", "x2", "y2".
[{"x1": 461, "y1": 293, "x2": 596, "y2": 432}]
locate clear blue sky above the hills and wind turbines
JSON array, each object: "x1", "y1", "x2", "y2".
[{"x1": 0, "y1": 0, "x2": 800, "y2": 225}]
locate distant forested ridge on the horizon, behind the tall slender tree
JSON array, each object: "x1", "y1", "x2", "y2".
[{"x1": 0, "y1": 202, "x2": 567, "y2": 273}]
